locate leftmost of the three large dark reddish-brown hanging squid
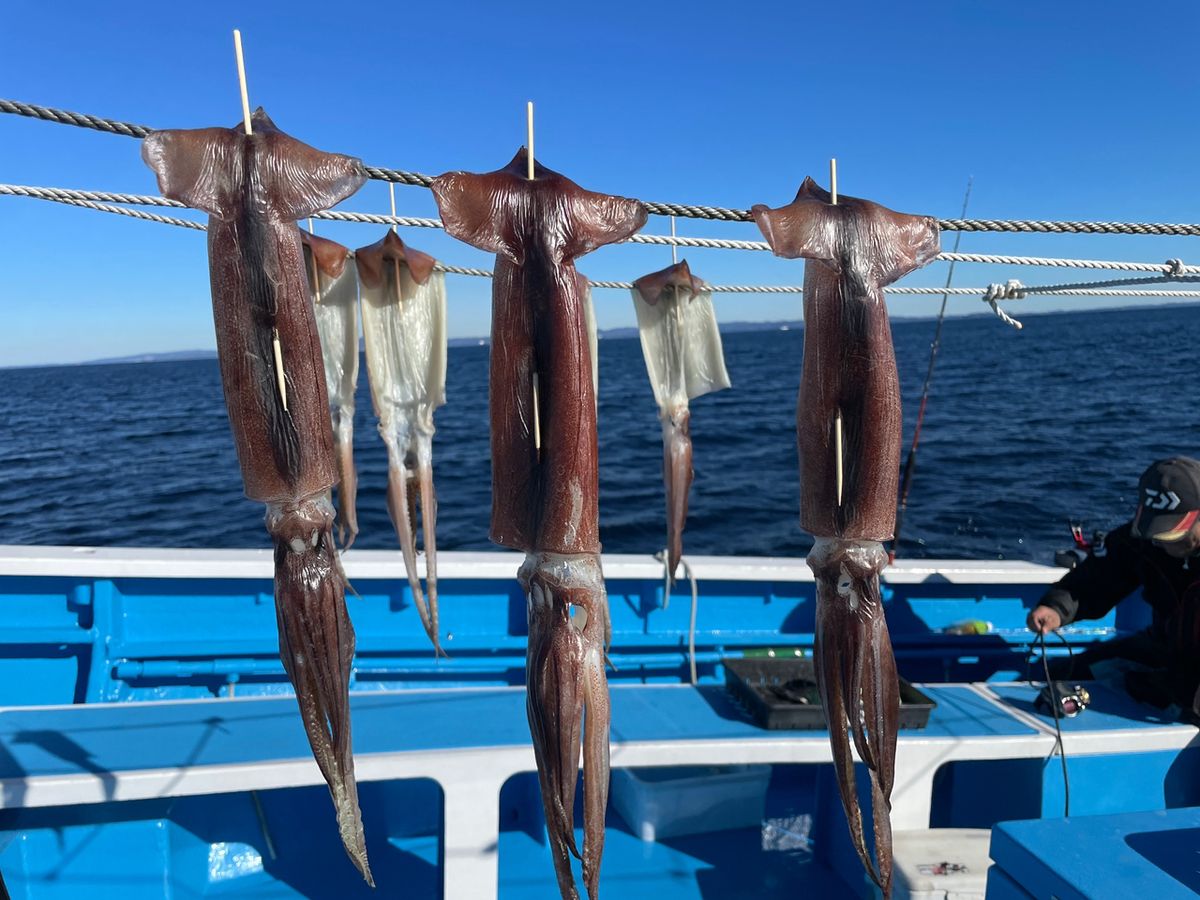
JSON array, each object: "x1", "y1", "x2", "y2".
[{"x1": 142, "y1": 109, "x2": 373, "y2": 883}]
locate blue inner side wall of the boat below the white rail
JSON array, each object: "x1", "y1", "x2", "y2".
[{"x1": 0, "y1": 576, "x2": 1113, "y2": 706}]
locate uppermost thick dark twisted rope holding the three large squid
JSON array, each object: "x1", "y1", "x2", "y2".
[{"x1": 7, "y1": 98, "x2": 1200, "y2": 235}]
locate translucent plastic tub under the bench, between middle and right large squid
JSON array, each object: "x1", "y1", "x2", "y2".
[{"x1": 612, "y1": 766, "x2": 770, "y2": 841}]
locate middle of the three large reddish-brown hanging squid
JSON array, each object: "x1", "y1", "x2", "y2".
[{"x1": 433, "y1": 149, "x2": 646, "y2": 899}]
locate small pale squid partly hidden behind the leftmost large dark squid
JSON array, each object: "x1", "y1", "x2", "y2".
[{"x1": 300, "y1": 230, "x2": 359, "y2": 550}]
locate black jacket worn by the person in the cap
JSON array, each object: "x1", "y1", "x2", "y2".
[{"x1": 1042, "y1": 522, "x2": 1200, "y2": 709}]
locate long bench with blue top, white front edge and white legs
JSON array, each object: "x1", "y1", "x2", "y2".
[{"x1": 0, "y1": 684, "x2": 1196, "y2": 898}]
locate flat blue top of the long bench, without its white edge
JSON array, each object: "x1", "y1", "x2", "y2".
[{"x1": 0, "y1": 685, "x2": 1032, "y2": 779}]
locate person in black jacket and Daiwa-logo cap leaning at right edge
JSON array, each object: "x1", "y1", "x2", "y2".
[{"x1": 1027, "y1": 456, "x2": 1200, "y2": 718}]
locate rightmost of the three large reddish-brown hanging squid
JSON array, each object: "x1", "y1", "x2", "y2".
[{"x1": 751, "y1": 179, "x2": 938, "y2": 895}]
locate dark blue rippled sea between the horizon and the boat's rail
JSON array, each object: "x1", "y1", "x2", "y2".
[{"x1": 0, "y1": 306, "x2": 1200, "y2": 563}]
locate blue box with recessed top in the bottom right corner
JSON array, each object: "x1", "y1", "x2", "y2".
[{"x1": 988, "y1": 809, "x2": 1200, "y2": 900}]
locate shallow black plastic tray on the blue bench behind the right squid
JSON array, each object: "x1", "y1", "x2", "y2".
[{"x1": 724, "y1": 656, "x2": 937, "y2": 730}]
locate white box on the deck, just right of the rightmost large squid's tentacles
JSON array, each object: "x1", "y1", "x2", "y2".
[{"x1": 872, "y1": 828, "x2": 991, "y2": 900}]
